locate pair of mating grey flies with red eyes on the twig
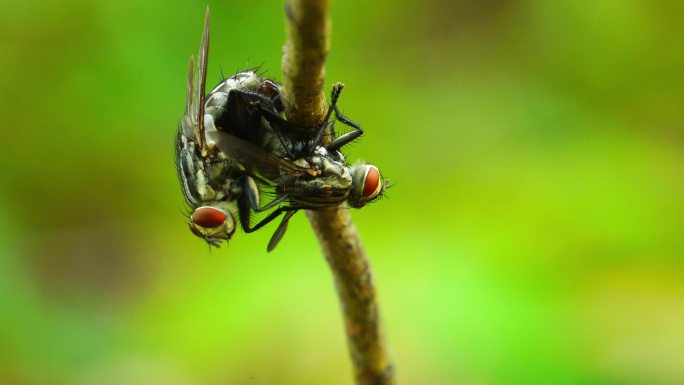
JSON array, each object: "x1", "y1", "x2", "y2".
[{"x1": 175, "y1": 9, "x2": 386, "y2": 251}]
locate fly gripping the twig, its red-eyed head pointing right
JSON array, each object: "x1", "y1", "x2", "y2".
[{"x1": 208, "y1": 83, "x2": 387, "y2": 251}]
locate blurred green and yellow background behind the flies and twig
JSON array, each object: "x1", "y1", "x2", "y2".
[{"x1": 0, "y1": 0, "x2": 684, "y2": 385}]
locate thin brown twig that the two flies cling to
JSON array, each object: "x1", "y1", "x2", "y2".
[{"x1": 282, "y1": 0, "x2": 394, "y2": 385}]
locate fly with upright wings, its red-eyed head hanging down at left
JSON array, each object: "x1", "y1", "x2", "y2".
[{"x1": 175, "y1": 8, "x2": 292, "y2": 247}]
